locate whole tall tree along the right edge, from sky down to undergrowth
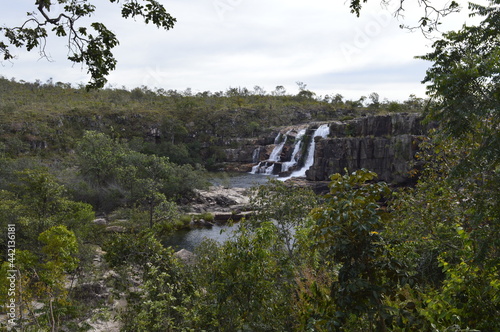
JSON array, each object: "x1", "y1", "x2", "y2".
[{"x1": 421, "y1": 0, "x2": 500, "y2": 263}]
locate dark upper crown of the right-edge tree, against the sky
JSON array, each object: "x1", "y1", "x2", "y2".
[{"x1": 419, "y1": 0, "x2": 500, "y2": 169}]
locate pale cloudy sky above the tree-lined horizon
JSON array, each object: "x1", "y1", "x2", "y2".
[{"x1": 0, "y1": 0, "x2": 480, "y2": 100}]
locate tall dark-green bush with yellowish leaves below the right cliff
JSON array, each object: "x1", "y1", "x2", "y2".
[{"x1": 312, "y1": 170, "x2": 400, "y2": 330}]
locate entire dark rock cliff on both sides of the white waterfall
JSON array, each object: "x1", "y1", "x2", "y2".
[{"x1": 227, "y1": 113, "x2": 427, "y2": 183}]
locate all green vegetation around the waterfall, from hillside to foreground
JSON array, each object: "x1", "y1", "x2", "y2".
[{"x1": 0, "y1": 1, "x2": 500, "y2": 331}]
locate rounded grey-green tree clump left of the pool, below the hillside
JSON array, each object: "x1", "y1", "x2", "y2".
[{"x1": 75, "y1": 132, "x2": 206, "y2": 211}]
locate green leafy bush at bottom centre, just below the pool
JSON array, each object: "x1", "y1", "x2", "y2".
[{"x1": 192, "y1": 222, "x2": 296, "y2": 331}]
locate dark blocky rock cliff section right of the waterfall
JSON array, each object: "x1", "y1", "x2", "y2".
[{"x1": 306, "y1": 114, "x2": 426, "y2": 183}]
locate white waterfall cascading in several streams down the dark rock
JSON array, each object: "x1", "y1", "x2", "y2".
[{"x1": 250, "y1": 124, "x2": 330, "y2": 180}]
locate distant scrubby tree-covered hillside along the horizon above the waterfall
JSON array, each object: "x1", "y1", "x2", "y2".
[{"x1": 0, "y1": 78, "x2": 424, "y2": 169}]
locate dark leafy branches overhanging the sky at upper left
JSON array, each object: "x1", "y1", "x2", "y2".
[{"x1": 0, "y1": 0, "x2": 176, "y2": 89}]
